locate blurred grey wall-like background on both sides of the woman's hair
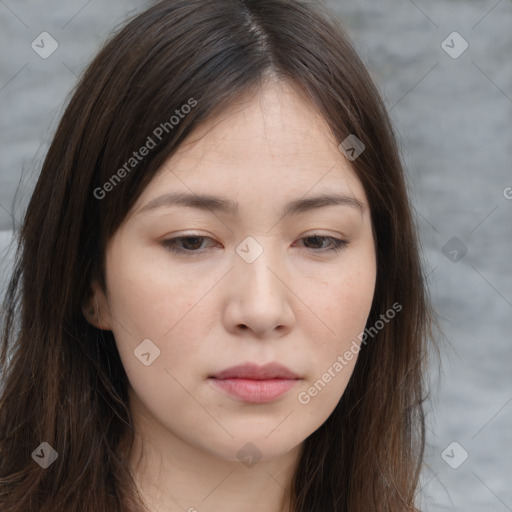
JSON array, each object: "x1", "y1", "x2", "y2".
[{"x1": 0, "y1": 0, "x2": 512, "y2": 512}]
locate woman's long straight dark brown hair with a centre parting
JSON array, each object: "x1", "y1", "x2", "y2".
[{"x1": 0, "y1": 0, "x2": 432, "y2": 512}]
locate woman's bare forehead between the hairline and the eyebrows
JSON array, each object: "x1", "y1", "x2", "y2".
[{"x1": 130, "y1": 82, "x2": 365, "y2": 214}]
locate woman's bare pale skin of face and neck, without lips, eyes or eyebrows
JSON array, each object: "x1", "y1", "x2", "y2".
[{"x1": 89, "y1": 80, "x2": 376, "y2": 512}]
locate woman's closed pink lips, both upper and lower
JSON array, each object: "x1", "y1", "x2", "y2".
[{"x1": 208, "y1": 363, "x2": 301, "y2": 403}]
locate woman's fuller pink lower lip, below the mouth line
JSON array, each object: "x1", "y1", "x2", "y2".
[{"x1": 208, "y1": 378, "x2": 299, "y2": 404}]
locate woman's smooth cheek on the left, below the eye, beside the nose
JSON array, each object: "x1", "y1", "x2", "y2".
[{"x1": 103, "y1": 244, "x2": 220, "y2": 396}]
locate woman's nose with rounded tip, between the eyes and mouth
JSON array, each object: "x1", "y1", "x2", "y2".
[{"x1": 223, "y1": 241, "x2": 295, "y2": 339}]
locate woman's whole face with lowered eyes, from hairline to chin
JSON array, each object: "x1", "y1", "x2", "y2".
[{"x1": 90, "y1": 82, "x2": 376, "y2": 464}]
